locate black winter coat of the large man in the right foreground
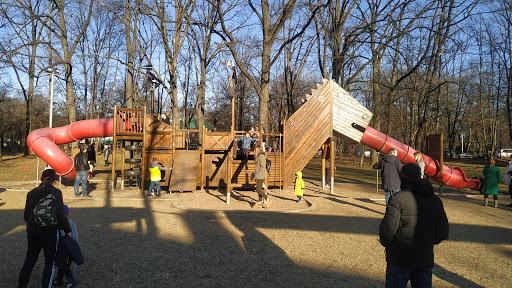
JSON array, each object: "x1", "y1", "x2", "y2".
[{"x1": 379, "y1": 178, "x2": 448, "y2": 269}]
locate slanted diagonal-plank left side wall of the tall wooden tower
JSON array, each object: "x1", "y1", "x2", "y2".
[{"x1": 283, "y1": 81, "x2": 333, "y2": 187}]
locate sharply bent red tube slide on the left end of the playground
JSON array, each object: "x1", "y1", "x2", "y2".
[{"x1": 27, "y1": 119, "x2": 114, "y2": 180}]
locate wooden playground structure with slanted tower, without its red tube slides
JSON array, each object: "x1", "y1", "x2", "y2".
[{"x1": 111, "y1": 80, "x2": 372, "y2": 204}]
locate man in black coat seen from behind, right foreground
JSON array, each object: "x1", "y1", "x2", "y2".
[{"x1": 379, "y1": 163, "x2": 448, "y2": 288}]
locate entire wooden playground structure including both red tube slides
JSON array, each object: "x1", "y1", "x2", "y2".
[{"x1": 27, "y1": 80, "x2": 480, "y2": 203}]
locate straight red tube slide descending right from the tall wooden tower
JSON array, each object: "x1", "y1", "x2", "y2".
[{"x1": 361, "y1": 127, "x2": 481, "y2": 190}]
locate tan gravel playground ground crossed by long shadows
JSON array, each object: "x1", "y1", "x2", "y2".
[{"x1": 0, "y1": 173, "x2": 512, "y2": 287}]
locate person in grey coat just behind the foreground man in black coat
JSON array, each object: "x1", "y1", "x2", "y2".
[{"x1": 373, "y1": 148, "x2": 402, "y2": 205}]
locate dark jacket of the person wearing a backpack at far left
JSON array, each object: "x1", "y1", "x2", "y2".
[{"x1": 23, "y1": 185, "x2": 71, "y2": 233}]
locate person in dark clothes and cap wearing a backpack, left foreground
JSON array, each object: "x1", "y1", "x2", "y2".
[{"x1": 18, "y1": 169, "x2": 71, "y2": 287}]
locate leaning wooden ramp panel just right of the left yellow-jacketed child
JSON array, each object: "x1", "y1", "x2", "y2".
[{"x1": 169, "y1": 150, "x2": 201, "y2": 191}]
